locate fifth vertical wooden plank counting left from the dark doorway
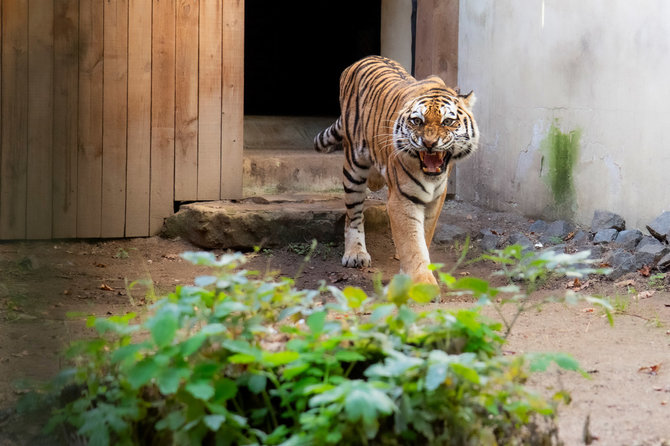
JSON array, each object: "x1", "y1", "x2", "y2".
[{"x1": 126, "y1": 0, "x2": 151, "y2": 237}]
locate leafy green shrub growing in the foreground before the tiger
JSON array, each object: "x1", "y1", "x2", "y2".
[{"x1": 43, "y1": 246, "x2": 608, "y2": 446}]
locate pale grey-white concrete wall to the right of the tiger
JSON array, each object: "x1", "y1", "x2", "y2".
[{"x1": 457, "y1": 0, "x2": 670, "y2": 229}]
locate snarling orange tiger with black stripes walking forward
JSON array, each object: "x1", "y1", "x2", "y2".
[{"x1": 314, "y1": 56, "x2": 479, "y2": 284}]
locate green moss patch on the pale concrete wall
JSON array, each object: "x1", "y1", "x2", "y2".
[{"x1": 540, "y1": 123, "x2": 581, "y2": 217}]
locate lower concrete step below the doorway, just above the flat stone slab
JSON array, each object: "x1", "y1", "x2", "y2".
[{"x1": 243, "y1": 150, "x2": 344, "y2": 197}]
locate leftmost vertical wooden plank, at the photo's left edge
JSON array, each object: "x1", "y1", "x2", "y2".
[{"x1": 0, "y1": 0, "x2": 28, "y2": 239}]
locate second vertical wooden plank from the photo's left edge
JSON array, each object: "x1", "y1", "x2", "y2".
[{"x1": 26, "y1": 0, "x2": 54, "y2": 239}]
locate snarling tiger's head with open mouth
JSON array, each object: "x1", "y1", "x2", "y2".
[{"x1": 393, "y1": 87, "x2": 479, "y2": 176}]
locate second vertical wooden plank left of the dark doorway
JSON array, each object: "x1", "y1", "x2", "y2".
[{"x1": 198, "y1": 0, "x2": 223, "y2": 200}]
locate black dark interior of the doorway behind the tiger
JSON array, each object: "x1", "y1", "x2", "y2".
[{"x1": 244, "y1": 0, "x2": 381, "y2": 116}]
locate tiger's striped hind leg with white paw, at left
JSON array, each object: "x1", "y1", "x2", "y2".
[{"x1": 342, "y1": 141, "x2": 371, "y2": 268}]
